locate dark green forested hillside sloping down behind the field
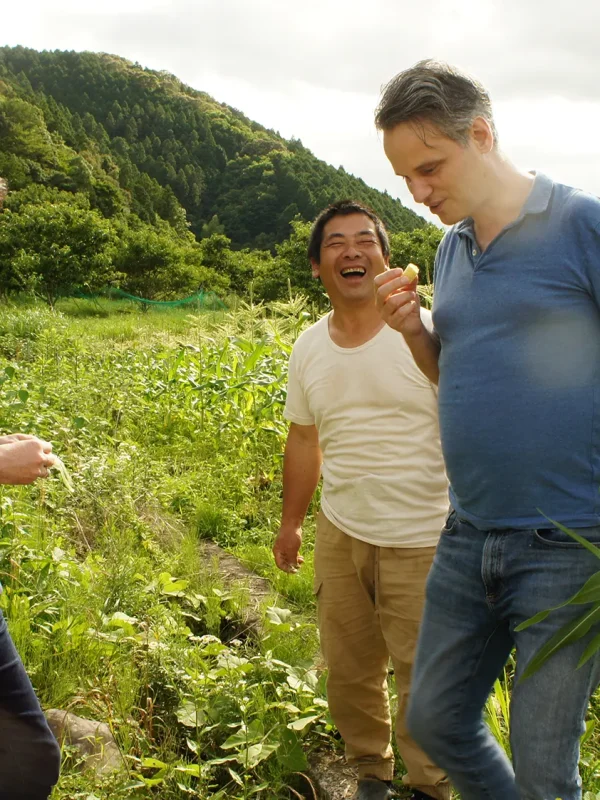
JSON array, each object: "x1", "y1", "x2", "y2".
[{"x1": 0, "y1": 47, "x2": 439, "y2": 300}]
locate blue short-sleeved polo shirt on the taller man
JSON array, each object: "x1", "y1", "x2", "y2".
[{"x1": 433, "y1": 174, "x2": 600, "y2": 530}]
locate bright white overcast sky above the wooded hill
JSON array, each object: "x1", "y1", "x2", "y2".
[{"x1": 0, "y1": 0, "x2": 600, "y2": 225}]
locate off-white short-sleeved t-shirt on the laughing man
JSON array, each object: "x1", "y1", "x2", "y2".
[{"x1": 284, "y1": 309, "x2": 448, "y2": 547}]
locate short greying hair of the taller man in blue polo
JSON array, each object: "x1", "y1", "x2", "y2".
[{"x1": 375, "y1": 59, "x2": 498, "y2": 144}]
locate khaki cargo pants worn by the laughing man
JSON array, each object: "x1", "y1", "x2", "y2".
[{"x1": 315, "y1": 511, "x2": 450, "y2": 800}]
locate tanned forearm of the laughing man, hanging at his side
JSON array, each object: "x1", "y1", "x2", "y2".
[{"x1": 281, "y1": 433, "x2": 322, "y2": 528}]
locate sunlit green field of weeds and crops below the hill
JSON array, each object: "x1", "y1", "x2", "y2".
[{"x1": 0, "y1": 299, "x2": 600, "y2": 800}]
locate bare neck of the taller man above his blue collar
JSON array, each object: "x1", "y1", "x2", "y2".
[{"x1": 473, "y1": 155, "x2": 534, "y2": 250}]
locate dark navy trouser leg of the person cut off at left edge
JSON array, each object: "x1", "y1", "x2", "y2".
[{"x1": 0, "y1": 612, "x2": 60, "y2": 800}]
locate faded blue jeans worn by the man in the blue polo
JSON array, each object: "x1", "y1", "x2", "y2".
[{"x1": 407, "y1": 512, "x2": 600, "y2": 800}]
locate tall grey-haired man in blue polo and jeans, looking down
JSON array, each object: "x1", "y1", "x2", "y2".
[{"x1": 375, "y1": 61, "x2": 600, "y2": 800}]
